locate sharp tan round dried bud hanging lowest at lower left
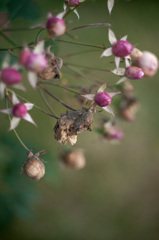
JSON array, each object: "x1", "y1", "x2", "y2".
[{"x1": 23, "y1": 156, "x2": 45, "y2": 180}]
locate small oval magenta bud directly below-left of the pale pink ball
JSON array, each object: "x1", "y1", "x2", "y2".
[{"x1": 125, "y1": 66, "x2": 144, "y2": 79}]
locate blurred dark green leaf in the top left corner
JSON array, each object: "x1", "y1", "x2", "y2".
[{"x1": 7, "y1": 0, "x2": 40, "y2": 21}]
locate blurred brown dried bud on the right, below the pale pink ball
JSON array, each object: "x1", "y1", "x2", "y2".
[{"x1": 119, "y1": 94, "x2": 139, "y2": 122}]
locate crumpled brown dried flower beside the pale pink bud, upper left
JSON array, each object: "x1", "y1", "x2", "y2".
[{"x1": 38, "y1": 46, "x2": 63, "y2": 80}]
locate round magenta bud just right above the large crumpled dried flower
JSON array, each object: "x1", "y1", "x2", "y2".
[{"x1": 94, "y1": 92, "x2": 112, "y2": 107}]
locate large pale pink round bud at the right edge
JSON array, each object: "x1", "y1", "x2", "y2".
[{"x1": 135, "y1": 51, "x2": 158, "y2": 77}]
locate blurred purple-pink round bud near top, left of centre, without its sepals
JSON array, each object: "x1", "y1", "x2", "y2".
[{"x1": 46, "y1": 17, "x2": 66, "y2": 36}]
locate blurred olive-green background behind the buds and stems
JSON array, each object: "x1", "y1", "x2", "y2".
[{"x1": 0, "y1": 0, "x2": 159, "y2": 240}]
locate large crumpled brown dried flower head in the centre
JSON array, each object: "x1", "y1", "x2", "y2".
[{"x1": 54, "y1": 106, "x2": 96, "y2": 145}]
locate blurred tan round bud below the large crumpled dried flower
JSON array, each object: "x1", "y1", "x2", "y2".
[{"x1": 62, "y1": 150, "x2": 86, "y2": 169}]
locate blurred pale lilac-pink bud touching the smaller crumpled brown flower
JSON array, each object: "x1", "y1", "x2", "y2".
[{"x1": 26, "y1": 53, "x2": 48, "y2": 72}]
